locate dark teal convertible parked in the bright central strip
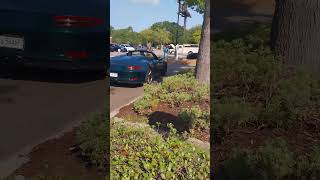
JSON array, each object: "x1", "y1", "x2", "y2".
[{"x1": 110, "y1": 50, "x2": 167, "y2": 84}]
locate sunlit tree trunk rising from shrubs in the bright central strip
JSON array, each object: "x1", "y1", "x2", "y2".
[{"x1": 195, "y1": 0, "x2": 210, "y2": 84}]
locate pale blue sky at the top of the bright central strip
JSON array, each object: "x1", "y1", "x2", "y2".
[{"x1": 110, "y1": 0, "x2": 203, "y2": 31}]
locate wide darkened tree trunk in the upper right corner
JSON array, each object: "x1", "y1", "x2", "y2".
[{"x1": 271, "y1": 0, "x2": 320, "y2": 72}]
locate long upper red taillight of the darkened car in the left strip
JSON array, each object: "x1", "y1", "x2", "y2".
[{"x1": 53, "y1": 16, "x2": 103, "y2": 28}]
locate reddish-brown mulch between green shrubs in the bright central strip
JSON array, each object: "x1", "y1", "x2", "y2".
[{"x1": 116, "y1": 101, "x2": 210, "y2": 142}]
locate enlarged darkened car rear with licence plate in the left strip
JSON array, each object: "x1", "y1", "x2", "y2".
[{"x1": 0, "y1": 0, "x2": 109, "y2": 72}]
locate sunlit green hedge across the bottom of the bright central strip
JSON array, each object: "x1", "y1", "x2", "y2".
[{"x1": 111, "y1": 123, "x2": 209, "y2": 179}]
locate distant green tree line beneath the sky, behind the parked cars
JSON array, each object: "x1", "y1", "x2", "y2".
[{"x1": 110, "y1": 21, "x2": 202, "y2": 46}]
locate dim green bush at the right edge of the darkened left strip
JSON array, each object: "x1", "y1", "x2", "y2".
[{"x1": 77, "y1": 113, "x2": 109, "y2": 167}]
